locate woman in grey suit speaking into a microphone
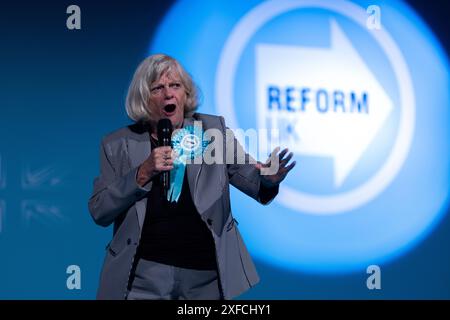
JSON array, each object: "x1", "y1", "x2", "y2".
[{"x1": 89, "y1": 54, "x2": 295, "y2": 299}]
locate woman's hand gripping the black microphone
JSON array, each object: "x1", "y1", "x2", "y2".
[{"x1": 136, "y1": 146, "x2": 175, "y2": 187}]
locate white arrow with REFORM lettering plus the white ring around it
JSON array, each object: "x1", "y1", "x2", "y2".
[{"x1": 216, "y1": 1, "x2": 415, "y2": 213}]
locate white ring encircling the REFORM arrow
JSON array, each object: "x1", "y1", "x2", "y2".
[{"x1": 215, "y1": 0, "x2": 415, "y2": 214}]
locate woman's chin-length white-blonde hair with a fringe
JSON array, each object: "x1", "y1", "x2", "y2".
[{"x1": 125, "y1": 54, "x2": 198, "y2": 122}]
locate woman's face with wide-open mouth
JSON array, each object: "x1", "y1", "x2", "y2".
[{"x1": 149, "y1": 72, "x2": 187, "y2": 130}]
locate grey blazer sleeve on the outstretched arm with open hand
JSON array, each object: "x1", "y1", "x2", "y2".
[{"x1": 220, "y1": 117, "x2": 279, "y2": 205}]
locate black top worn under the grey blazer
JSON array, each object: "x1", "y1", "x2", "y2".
[{"x1": 138, "y1": 139, "x2": 217, "y2": 270}]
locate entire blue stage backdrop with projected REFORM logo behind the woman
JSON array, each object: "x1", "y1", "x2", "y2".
[{"x1": 0, "y1": 0, "x2": 450, "y2": 299}]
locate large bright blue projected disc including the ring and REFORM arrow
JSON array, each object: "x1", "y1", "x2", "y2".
[{"x1": 150, "y1": 0, "x2": 450, "y2": 272}]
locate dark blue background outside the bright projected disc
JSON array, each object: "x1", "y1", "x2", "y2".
[{"x1": 0, "y1": 0, "x2": 450, "y2": 299}]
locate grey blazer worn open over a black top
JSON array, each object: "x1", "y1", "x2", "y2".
[{"x1": 88, "y1": 113, "x2": 278, "y2": 299}]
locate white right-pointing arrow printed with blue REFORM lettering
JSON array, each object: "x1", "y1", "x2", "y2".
[{"x1": 256, "y1": 21, "x2": 392, "y2": 187}]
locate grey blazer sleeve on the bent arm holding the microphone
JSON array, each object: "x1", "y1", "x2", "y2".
[{"x1": 88, "y1": 140, "x2": 151, "y2": 227}]
